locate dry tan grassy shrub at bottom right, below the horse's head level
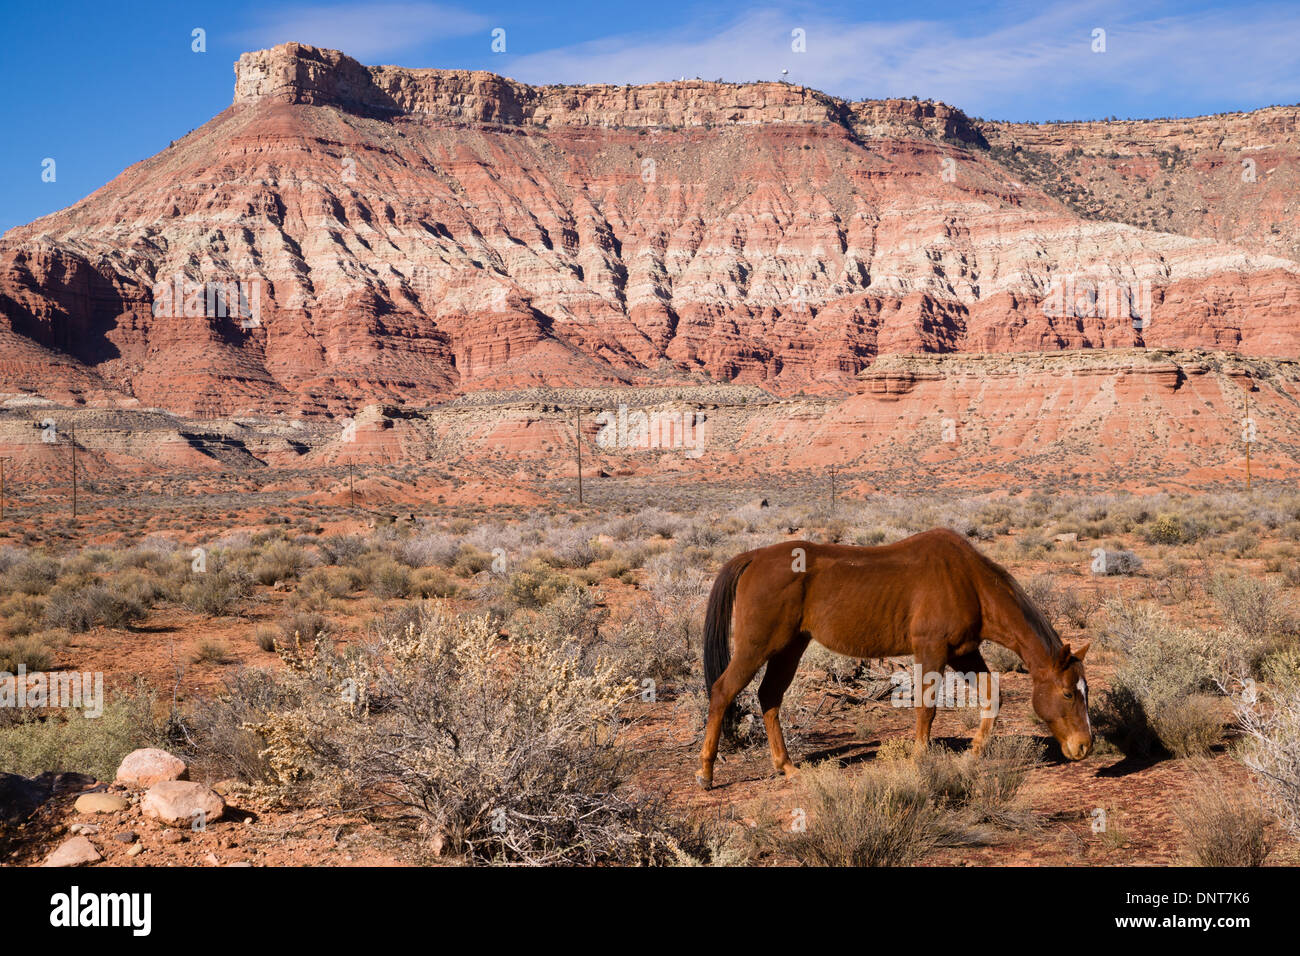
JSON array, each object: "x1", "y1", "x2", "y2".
[{"x1": 1178, "y1": 766, "x2": 1270, "y2": 866}]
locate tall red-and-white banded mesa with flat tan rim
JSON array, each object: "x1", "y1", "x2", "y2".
[{"x1": 0, "y1": 44, "x2": 1300, "y2": 414}]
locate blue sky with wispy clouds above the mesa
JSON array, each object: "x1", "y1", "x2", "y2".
[{"x1": 0, "y1": 0, "x2": 1300, "y2": 230}]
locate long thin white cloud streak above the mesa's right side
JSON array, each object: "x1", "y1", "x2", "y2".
[{"x1": 508, "y1": 0, "x2": 1300, "y2": 118}]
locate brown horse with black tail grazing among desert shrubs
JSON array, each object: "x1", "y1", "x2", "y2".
[{"x1": 696, "y1": 528, "x2": 1092, "y2": 788}]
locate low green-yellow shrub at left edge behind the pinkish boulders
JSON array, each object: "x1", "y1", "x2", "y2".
[{"x1": 0, "y1": 689, "x2": 163, "y2": 780}]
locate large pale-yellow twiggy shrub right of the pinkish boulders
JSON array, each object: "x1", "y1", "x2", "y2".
[{"x1": 255, "y1": 607, "x2": 668, "y2": 864}]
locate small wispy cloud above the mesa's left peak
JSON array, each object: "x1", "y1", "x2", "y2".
[{"x1": 239, "y1": 3, "x2": 489, "y2": 64}]
